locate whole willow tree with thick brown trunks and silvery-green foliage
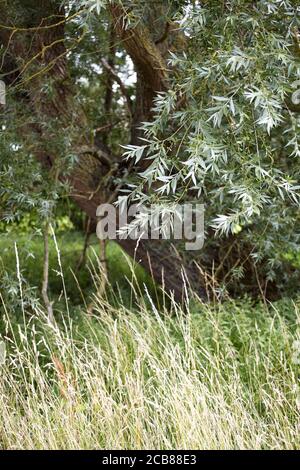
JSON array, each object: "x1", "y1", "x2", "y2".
[{"x1": 0, "y1": 0, "x2": 300, "y2": 296}]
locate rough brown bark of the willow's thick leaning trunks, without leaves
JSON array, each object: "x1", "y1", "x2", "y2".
[{"x1": 0, "y1": 0, "x2": 205, "y2": 300}]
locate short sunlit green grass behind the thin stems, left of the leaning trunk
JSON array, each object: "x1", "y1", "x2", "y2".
[{"x1": 0, "y1": 230, "x2": 153, "y2": 306}]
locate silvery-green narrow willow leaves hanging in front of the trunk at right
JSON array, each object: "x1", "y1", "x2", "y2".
[{"x1": 121, "y1": 1, "x2": 300, "y2": 290}]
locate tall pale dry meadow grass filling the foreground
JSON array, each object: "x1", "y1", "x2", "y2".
[{"x1": 0, "y1": 233, "x2": 300, "y2": 449}]
